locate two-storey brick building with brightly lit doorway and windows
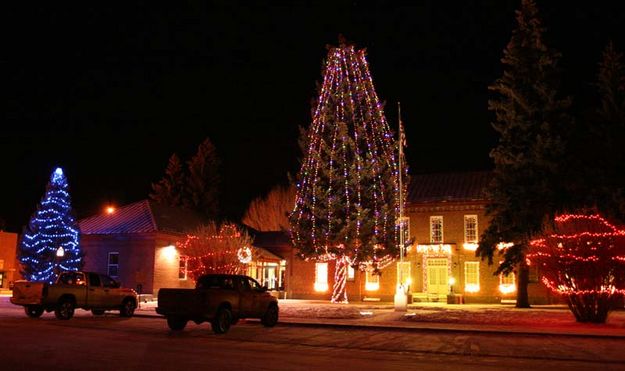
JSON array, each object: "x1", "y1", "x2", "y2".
[{"x1": 287, "y1": 172, "x2": 557, "y2": 303}]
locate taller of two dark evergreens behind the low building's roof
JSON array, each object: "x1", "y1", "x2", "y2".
[{"x1": 183, "y1": 138, "x2": 220, "y2": 220}]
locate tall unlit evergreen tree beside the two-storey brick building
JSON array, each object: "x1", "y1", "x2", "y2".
[{"x1": 477, "y1": 0, "x2": 570, "y2": 307}]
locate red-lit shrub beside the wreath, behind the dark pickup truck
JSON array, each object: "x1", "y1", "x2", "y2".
[{"x1": 177, "y1": 223, "x2": 255, "y2": 280}]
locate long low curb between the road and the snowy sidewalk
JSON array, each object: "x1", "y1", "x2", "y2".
[{"x1": 134, "y1": 312, "x2": 625, "y2": 339}]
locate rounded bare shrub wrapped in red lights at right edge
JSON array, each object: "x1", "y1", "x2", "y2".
[{"x1": 527, "y1": 215, "x2": 625, "y2": 323}]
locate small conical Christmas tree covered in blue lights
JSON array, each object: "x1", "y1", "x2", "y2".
[{"x1": 19, "y1": 168, "x2": 83, "y2": 282}]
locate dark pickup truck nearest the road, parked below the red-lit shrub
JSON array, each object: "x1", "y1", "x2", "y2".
[{"x1": 156, "y1": 274, "x2": 278, "y2": 334}]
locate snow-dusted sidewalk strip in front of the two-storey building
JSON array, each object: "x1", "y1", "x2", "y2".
[{"x1": 135, "y1": 300, "x2": 625, "y2": 339}]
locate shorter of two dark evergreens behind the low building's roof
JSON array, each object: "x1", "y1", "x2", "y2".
[{"x1": 150, "y1": 153, "x2": 185, "y2": 207}]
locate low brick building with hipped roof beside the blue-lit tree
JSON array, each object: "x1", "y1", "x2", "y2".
[{"x1": 79, "y1": 200, "x2": 205, "y2": 294}]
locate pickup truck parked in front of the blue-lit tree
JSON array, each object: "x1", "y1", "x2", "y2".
[{"x1": 11, "y1": 272, "x2": 137, "y2": 320}]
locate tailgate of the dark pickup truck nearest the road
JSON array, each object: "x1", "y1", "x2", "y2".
[{"x1": 156, "y1": 289, "x2": 204, "y2": 318}]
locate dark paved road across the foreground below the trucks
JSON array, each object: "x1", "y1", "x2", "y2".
[{"x1": 0, "y1": 307, "x2": 625, "y2": 371}]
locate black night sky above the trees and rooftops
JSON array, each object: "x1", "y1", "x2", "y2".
[{"x1": 0, "y1": 0, "x2": 625, "y2": 232}]
